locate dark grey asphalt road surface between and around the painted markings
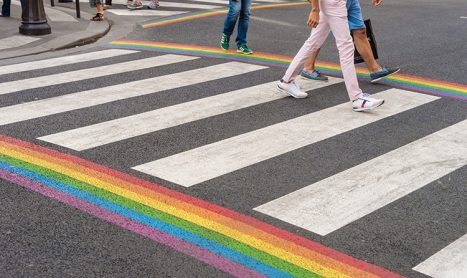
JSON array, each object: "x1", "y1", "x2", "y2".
[{"x1": 0, "y1": 0, "x2": 467, "y2": 277}]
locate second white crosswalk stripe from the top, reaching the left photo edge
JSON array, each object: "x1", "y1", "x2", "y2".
[{"x1": 0, "y1": 54, "x2": 196, "y2": 95}]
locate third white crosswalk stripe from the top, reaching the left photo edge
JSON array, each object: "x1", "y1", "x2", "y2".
[{"x1": 0, "y1": 62, "x2": 266, "y2": 125}]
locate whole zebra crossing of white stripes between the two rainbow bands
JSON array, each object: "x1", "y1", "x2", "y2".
[{"x1": 0, "y1": 49, "x2": 467, "y2": 277}]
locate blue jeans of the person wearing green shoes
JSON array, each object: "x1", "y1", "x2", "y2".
[{"x1": 223, "y1": 0, "x2": 251, "y2": 46}]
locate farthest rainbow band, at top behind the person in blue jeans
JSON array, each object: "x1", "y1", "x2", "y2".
[{"x1": 141, "y1": 0, "x2": 309, "y2": 29}]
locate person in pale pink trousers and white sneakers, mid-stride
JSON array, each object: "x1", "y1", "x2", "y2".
[{"x1": 277, "y1": 0, "x2": 384, "y2": 111}]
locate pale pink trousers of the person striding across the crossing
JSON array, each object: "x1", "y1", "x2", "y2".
[{"x1": 282, "y1": 0, "x2": 362, "y2": 100}]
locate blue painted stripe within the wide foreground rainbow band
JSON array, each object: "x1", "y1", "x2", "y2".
[{"x1": 0, "y1": 161, "x2": 292, "y2": 277}]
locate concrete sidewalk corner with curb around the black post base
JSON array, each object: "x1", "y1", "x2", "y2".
[{"x1": 0, "y1": 0, "x2": 110, "y2": 60}]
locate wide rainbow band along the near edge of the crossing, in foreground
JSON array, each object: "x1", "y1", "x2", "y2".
[{"x1": 0, "y1": 135, "x2": 401, "y2": 278}]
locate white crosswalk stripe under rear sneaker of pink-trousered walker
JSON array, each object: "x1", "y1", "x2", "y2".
[{"x1": 39, "y1": 78, "x2": 342, "y2": 151}]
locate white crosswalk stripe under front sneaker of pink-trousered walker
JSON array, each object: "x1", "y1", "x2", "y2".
[{"x1": 134, "y1": 89, "x2": 438, "y2": 187}]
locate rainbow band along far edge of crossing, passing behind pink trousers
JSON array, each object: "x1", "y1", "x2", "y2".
[{"x1": 110, "y1": 40, "x2": 467, "y2": 101}]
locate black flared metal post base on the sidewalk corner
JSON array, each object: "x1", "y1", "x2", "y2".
[{"x1": 19, "y1": 0, "x2": 52, "y2": 36}]
